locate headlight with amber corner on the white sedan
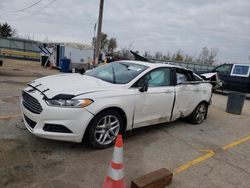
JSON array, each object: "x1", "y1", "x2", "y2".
[{"x1": 45, "y1": 99, "x2": 94, "y2": 108}]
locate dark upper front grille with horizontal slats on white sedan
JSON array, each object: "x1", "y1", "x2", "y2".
[{"x1": 22, "y1": 91, "x2": 43, "y2": 114}]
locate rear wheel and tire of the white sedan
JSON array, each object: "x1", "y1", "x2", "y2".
[{"x1": 188, "y1": 102, "x2": 208, "y2": 124}]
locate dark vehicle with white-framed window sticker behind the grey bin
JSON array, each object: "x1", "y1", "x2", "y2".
[{"x1": 197, "y1": 64, "x2": 250, "y2": 93}]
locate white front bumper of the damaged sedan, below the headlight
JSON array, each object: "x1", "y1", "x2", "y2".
[{"x1": 21, "y1": 91, "x2": 93, "y2": 142}]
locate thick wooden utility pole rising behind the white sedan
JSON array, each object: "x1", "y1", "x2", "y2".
[{"x1": 94, "y1": 0, "x2": 104, "y2": 66}]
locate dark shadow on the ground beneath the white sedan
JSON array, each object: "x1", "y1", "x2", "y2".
[{"x1": 13, "y1": 120, "x2": 193, "y2": 154}]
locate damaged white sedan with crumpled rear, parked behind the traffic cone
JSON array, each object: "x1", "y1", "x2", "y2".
[{"x1": 21, "y1": 61, "x2": 212, "y2": 148}]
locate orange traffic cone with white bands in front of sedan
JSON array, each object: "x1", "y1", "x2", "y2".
[{"x1": 103, "y1": 135, "x2": 125, "y2": 188}]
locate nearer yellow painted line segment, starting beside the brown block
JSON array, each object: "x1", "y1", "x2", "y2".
[{"x1": 174, "y1": 150, "x2": 215, "y2": 175}]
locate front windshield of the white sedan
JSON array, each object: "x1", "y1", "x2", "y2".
[{"x1": 85, "y1": 62, "x2": 148, "y2": 84}]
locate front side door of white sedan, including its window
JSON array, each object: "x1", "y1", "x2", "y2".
[{"x1": 133, "y1": 67, "x2": 174, "y2": 128}]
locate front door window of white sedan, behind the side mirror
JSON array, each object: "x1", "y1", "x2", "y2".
[{"x1": 137, "y1": 68, "x2": 171, "y2": 87}]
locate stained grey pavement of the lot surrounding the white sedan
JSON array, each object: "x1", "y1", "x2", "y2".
[{"x1": 0, "y1": 63, "x2": 250, "y2": 188}]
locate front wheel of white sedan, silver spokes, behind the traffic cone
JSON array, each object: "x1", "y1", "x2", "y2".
[{"x1": 87, "y1": 109, "x2": 123, "y2": 149}]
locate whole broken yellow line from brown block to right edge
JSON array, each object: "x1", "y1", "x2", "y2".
[{"x1": 174, "y1": 135, "x2": 250, "y2": 175}]
